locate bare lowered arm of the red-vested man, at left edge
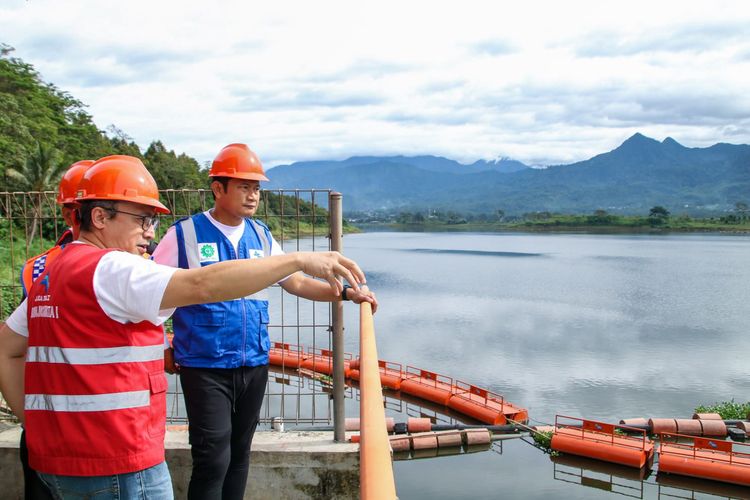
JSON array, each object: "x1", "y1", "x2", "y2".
[{"x1": 0, "y1": 324, "x2": 28, "y2": 423}]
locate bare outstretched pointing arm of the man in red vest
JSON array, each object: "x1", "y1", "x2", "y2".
[{"x1": 160, "y1": 252, "x2": 365, "y2": 309}]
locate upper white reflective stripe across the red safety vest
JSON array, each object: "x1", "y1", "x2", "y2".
[{"x1": 26, "y1": 344, "x2": 164, "y2": 365}]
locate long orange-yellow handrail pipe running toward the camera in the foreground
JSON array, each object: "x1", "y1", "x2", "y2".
[{"x1": 359, "y1": 292, "x2": 397, "y2": 500}]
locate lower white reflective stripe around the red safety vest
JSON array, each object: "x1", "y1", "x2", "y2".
[{"x1": 24, "y1": 390, "x2": 151, "y2": 412}]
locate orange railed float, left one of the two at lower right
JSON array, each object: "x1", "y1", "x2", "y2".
[{"x1": 550, "y1": 415, "x2": 654, "y2": 468}]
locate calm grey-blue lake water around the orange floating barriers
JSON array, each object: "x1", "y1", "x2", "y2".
[{"x1": 344, "y1": 232, "x2": 750, "y2": 499}]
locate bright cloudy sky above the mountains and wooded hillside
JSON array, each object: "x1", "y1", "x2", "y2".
[{"x1": 0, "y1": 0, "x2": 750, "y2": 166}]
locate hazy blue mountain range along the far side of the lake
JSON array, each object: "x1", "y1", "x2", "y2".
[{"x1": 264, "y1": 133, "x2": 750, "y2": 215}]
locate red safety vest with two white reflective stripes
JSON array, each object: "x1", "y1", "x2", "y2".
[{"x1": 24, "y1": 244, "x2": 167, "y2": 476}]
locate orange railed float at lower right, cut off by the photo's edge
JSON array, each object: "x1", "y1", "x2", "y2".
[{"x1": 659, "y1": 433, "x2": 750, "y2": 486}]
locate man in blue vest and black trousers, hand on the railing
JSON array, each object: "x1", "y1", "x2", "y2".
[{"x1": 153, "y1": 144, "x2": 377, "y2": 500}]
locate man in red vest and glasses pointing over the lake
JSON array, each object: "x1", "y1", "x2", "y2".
[{"x1": 0, "y1": 156, "x2": 364, "y2": 499}]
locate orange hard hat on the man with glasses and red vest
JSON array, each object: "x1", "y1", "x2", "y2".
[{"x1": 76, "y1": 155, "x2": 169, "y2": 214}]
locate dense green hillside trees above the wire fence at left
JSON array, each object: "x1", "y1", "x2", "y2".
[{"x1": 0, "y1": 44, "x2": 207, "y2": 191}]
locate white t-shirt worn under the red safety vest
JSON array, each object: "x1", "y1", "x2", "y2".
[{"x1": 6, "y1": 241, "x2": 177, "y2": 337}]
